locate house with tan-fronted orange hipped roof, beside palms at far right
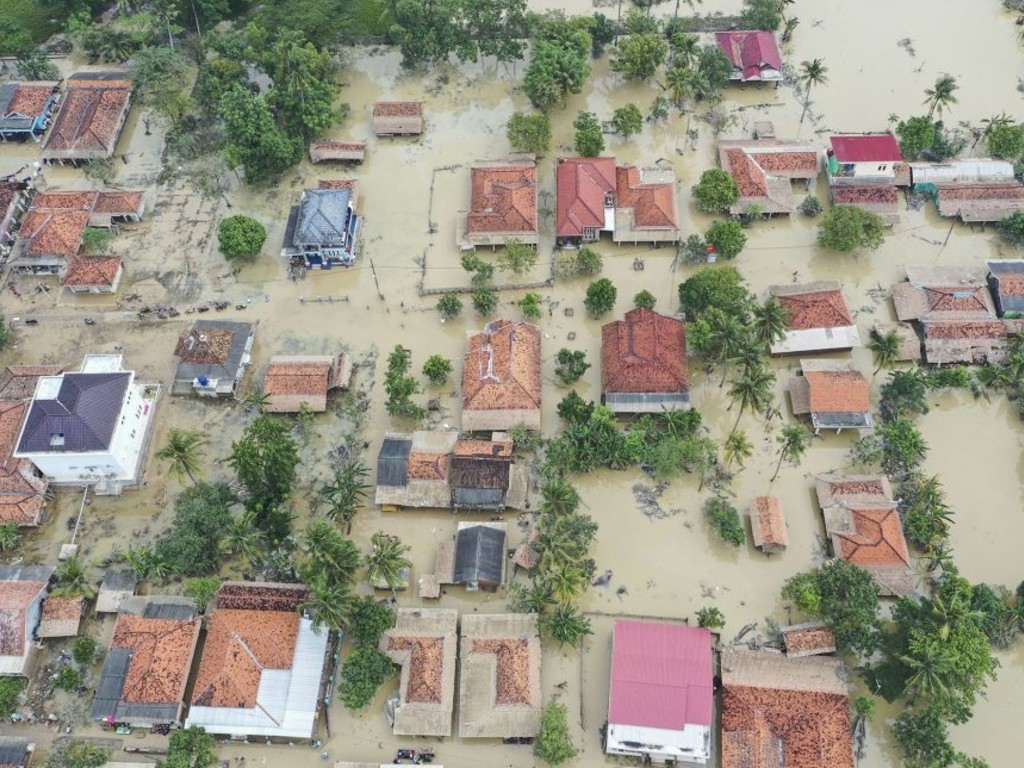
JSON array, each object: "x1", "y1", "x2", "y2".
[{"x1": 814, "y1": 475, "x2": 915, "y2": 597}]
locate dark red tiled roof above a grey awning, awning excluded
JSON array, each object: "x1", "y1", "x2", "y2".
[{"x1": 601, "y1": 307, "x2": 689, "y2": 392}]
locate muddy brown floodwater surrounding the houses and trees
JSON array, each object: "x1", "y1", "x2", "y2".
[{"x1": 6, "y1": 0, "x2": 1024, "y2": 768}]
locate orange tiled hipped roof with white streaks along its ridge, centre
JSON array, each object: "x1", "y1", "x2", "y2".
[{"x1": 462, "y1": 319, "x2": 541, "y2": 411}]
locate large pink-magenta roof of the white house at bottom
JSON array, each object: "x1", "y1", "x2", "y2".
[{"x1": 608, "y1": 620, "x2": 714, "y2": 731}]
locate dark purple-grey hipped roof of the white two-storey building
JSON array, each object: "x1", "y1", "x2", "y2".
[{"x1": 17, "y1": 373, "x2": 131, "y2": 454}]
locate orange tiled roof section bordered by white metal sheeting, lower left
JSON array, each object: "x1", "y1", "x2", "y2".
[{"x1": 191, "y1": 609, "x2": 299, "y2": 709}]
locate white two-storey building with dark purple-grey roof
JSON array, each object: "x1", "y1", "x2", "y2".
[{"x1": 14, "y1": 354, "x2": 156, "y2": 494}]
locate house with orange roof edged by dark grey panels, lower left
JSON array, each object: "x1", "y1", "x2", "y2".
[{"x1": 90, "y1": 595, "x2": 201, "y2": 727}]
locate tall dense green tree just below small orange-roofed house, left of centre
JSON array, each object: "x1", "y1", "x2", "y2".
[{"x1": 227, "y1": 414, "x2": 299, "y2": 543}]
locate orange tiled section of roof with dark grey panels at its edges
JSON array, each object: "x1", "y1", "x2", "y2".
[{"x1": 111, "y1": 613, "x2": 200, "y2": 703}]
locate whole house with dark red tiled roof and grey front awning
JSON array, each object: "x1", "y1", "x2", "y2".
[{"x1": 601, "y1": 307, "x2": 690, "y2": 414}]
